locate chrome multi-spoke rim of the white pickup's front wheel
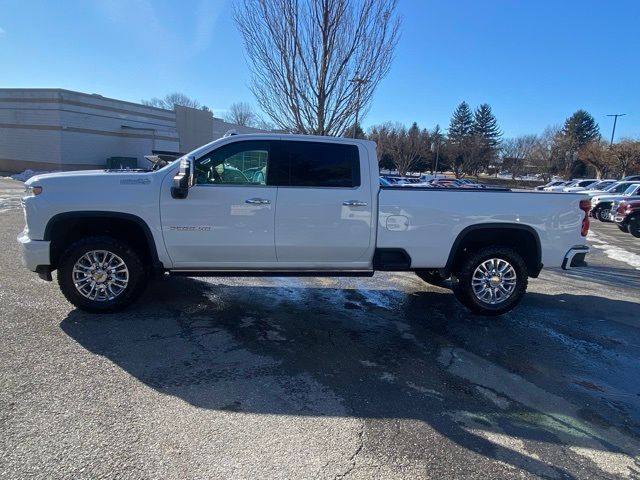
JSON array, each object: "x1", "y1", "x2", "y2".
[{"x1": 72, "y1": 250, "x2": 129, "y2": 302}]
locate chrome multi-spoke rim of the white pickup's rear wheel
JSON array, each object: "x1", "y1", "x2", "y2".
[{"x1": 471, "y1": 258, "x2": 518, "y2": 305}]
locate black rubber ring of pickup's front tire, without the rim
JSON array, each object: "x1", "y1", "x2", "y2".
[{"x1": 58, "y1": 237, "x2": 144, "y2": 313}]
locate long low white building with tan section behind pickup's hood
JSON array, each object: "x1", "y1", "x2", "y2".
[{"x1": 0, "y1": 88, "x2": 260, "y2": 172}]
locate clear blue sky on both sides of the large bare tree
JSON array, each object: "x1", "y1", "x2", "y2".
[{"x1": 0, "y1": 0, "x2": 640, "y2": 137}]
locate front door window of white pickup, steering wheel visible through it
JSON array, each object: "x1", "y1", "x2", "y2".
[{"x1": 195, "y1": 141, "x2": 271, "y2": 185}]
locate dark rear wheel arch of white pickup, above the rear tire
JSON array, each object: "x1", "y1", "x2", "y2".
[{"x1": 443, "y1": 223, "x2": 542, "y2": 278}]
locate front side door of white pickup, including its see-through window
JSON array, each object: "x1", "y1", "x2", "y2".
[{"x1": 160, "y1": 140, "x2": 277, "y2": 269}]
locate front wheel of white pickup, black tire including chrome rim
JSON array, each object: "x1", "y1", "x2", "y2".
[{"x1": 58, "y1": 236, "x2": 146, "y2": 313}]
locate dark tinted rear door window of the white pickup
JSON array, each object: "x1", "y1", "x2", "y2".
[{"x1": 274, "y1": 141, "x2": 360, "y2": 188}]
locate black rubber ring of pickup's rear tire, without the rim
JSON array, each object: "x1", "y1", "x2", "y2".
[{"x1": 454, "y1": 247, "x2": 528, "y2": 316}]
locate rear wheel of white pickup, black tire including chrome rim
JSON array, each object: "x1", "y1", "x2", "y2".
[{"x1": 453, "y1": 247, "x2": 529, "y2": 316}]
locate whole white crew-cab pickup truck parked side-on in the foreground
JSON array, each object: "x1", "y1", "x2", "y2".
[{"x1": 18, "y1": 134, "x2": 590, "y2": 315}]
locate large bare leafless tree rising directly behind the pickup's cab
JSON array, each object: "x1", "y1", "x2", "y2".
[{"x1": 235, "y1": 0, "x2": 400, "y2": 135}]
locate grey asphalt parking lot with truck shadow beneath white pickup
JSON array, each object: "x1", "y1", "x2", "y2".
[{"x1": 0, "y1": 180, "x2": 640, "y2": 479}]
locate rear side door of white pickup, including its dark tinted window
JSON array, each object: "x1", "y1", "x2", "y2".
[{"x1": 274, "y1": 140, "x2": 375, "y2": 269}]
